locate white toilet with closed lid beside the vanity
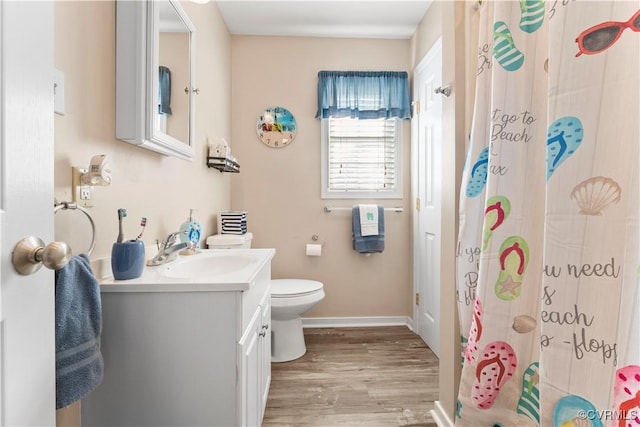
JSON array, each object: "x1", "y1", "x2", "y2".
[{"x1": 206, "y1": 233, "x2": 324, "y2": 362}]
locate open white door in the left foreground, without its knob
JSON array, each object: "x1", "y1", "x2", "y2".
[{"x1": 0, "y1": 1, "x2": 55, "y2": 426}]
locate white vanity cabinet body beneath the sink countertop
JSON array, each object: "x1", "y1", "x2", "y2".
[{"x1": 81, "y1": 249, "x2": 275, "y2": 427}]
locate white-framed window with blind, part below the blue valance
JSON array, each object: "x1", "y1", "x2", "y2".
[{"x1": 321, "y1": 117, "x2": 402, "y2": 199}]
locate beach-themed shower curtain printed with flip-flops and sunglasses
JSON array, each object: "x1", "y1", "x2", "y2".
[{"x1": 456, "y1": 0, "x2": 640, "y2": 427}]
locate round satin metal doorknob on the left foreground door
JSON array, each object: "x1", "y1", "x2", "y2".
[{"x1": 11, "y1": 236, "x2": 72, "y2": 276}]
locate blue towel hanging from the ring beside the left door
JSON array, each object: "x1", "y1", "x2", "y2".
[{"x1": 56, "y1": 254, "x2": 104, "y2": 409}]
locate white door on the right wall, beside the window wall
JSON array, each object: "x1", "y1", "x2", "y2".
[{"x1": 412, "y1": 39, "x2": 442, "y2": 355}]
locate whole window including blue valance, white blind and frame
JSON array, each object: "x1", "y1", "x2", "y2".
[{"x1": 316, "y1": 71, "x2": 411, "y2": 199}]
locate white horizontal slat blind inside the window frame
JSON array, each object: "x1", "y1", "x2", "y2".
[{"x1": 325, "y1": 118, "x2": 398, "y2": 192}]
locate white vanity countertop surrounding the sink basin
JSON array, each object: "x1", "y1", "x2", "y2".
[{"x1": 100, "y1": 248, "x2": 276, "y2": 293}]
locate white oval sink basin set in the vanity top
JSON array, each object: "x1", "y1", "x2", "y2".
[{"x1": 160, "y1": 252, "x2": 257, "y2": 279}]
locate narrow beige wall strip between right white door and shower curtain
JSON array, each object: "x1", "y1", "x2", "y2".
[{"x1": 411, "y1": 1, "x2": 477, "y2": 421}]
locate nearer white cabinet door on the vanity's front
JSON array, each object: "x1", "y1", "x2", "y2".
[{"x1": 238, "y1": 307, "x2": 263, "y2": 426}]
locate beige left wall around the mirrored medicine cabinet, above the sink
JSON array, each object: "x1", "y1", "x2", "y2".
[{"x1": 54, "y1": 1, "x2": 231, "y2": 426}]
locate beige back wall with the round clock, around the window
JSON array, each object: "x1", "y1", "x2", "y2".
[{"x1": 230, "y1": 36, "x2": 412, "y2": 317}]
